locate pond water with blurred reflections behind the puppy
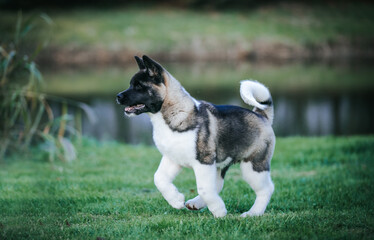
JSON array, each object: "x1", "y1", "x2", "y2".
[{"x1": 47, "y1": 62, "x2": 374, "y2": 144}]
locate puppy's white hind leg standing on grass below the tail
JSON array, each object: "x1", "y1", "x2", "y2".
[{"x1": 240, "y1": 162, "x2": 274, "y2": 217}]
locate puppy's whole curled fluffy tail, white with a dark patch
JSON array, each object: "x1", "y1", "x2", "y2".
[{"x1": 240, "y1": 80, "x2": 274, "y2": 124}]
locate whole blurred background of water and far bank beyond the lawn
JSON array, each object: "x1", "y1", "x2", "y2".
[{"x1": 0, "y1": 0, "x2": 374, "y2": 144}]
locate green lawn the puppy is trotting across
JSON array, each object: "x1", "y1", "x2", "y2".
[{"x1": 0, "y1": 136, "x2": 374, "y2": 239}]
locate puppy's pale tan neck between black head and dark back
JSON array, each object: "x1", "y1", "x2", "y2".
[{"x1": 151, "y1": 73, "x2": 199, "y2": 132}]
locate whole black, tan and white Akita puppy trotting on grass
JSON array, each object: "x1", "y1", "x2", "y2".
[{"x1": 117, "y1": 56, "x2": 275, "y2": 217}]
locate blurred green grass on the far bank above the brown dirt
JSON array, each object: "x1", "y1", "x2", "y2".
[{"x1": 0, "y1": 3, "x2": 374, "y2": 54}]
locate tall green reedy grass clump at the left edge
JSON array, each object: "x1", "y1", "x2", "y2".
[{"x1": 0, "y1": 12, "x2": 89, "y2": 161}]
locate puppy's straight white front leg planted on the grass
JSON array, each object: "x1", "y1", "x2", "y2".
[{"x1": 193, "y1": 163, "x2": 227, "y2": 217}]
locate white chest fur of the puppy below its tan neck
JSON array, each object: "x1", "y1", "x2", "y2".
[{"x1": 150, "y1": 113, "x2": 197, "y2": 167}]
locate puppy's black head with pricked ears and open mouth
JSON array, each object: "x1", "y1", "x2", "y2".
[{"x1": 117, "y1": 55, "x2": 167, "y2": 116}]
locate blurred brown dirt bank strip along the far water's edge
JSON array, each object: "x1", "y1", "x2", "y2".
[{"x1": 38, "y1": 41, "x2": 374, "y2": 66}]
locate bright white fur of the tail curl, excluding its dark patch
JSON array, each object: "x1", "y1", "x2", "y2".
[{"x1": 240, "y1": 80, "x2": 271, "y2": 110}]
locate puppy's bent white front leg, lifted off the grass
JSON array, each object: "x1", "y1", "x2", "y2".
[{"x1": 154, "y1": 156, "x2": 184, "y2": 209}]
